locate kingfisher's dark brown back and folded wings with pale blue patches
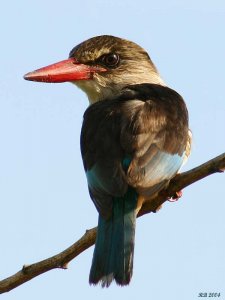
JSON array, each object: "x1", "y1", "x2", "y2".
[{"x1": 81, "y1": 85, "x2": 188, "y2": 215}]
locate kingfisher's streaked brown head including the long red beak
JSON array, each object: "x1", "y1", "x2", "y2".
[{"x1": 24, "y1": 35, "x2": 164, "y2": 103}]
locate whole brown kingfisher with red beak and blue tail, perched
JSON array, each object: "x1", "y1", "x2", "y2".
[{"x1": 24, "y1": 35, "x2": 191, "y2": 287}]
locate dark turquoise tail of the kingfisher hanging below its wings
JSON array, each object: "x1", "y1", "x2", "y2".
[{"x1": 89, "y1": 188, "x2": 137, "y2": 287}]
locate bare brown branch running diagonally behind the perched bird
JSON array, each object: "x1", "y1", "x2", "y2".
[{"x1": 0, "y1": 153, "x2": 225, "y2": 293}]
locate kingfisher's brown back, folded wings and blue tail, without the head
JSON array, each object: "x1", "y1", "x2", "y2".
[{"x1": 81, "y1": 84, "x2": 190, "y2": 287}]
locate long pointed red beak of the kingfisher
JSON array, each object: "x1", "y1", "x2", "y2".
[{"x1": 24, "y1": 58, "x2": 106, "y2": 82}]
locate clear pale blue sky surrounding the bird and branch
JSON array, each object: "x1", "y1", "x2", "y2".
[{"x1": 0, "y1": 0, "x2": 225, "y2": 300}]
